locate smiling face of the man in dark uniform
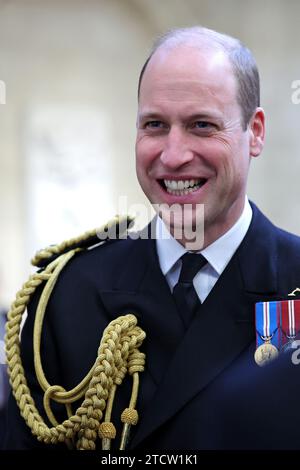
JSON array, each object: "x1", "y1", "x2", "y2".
[{"x1": 136, "y1": 46, "x2": 262, "y2": 246}]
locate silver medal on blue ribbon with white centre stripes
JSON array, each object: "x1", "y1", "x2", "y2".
[{"x1": 254, "y1": 302, "x2": 280, "y2": 366}]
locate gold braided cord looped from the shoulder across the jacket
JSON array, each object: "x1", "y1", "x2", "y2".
[{"x1": 5, "y1": 215, "x2": 145, "y2": 450}]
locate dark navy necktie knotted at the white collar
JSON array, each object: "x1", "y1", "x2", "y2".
[{"x1": 173, "y1": 253, "x2": 207, "y2": 328}]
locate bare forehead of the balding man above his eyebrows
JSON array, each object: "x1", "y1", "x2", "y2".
[{"x1": 139, "y1": 46, "x2": 237, "y2": 114}]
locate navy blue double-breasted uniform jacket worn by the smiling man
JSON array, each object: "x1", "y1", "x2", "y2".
[{"x1": 6, "y1": 205, "x2": 300, "y2": 451}]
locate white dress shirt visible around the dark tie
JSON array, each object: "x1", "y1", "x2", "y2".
[{"x1": 156, "y1": 197, "x2": 252, "y2": 303}]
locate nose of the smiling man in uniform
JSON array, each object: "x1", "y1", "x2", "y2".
[{"x1": 160, "y1": 128, "x2": 194, "y2": 170}]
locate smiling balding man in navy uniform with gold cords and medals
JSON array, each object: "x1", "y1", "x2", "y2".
[{"x1": 6, "y1": 27, "x2": 300, "y2": 452}]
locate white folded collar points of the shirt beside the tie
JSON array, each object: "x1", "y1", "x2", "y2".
[{"x1": 156, "y1": 197, "x2": 252, "y2": 276}]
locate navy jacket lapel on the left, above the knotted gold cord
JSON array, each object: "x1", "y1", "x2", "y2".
[{"x1": 100, "y1": 234, "x2": 184, "y2": 386}]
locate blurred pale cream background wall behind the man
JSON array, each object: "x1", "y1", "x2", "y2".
[{"x1": 0, "y1": 0, "x2": 300, "y2": 308}]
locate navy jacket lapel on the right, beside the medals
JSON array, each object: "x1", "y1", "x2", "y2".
[{"x1": 132, "y1": 208, "x2": 277, "y2": 447}]
